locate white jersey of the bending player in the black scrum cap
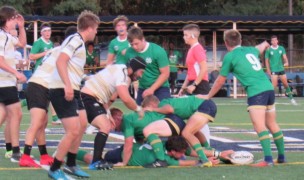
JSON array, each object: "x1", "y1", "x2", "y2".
[{"x1": 84, "y1": 64, "x2": 129, "y2": 104}]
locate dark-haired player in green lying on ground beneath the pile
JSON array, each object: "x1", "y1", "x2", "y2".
[{"x1": 77, "y1": 136, "x2": 234, "y2": 167}]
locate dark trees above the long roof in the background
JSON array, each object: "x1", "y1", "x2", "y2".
[{"x1": 0, "y1": 0, "x2": 304, "y2": 16}]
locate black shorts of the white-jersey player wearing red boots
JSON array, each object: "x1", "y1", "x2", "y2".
[{"x1": 25, "y1": 82, "x2": 50, "y2": 112}]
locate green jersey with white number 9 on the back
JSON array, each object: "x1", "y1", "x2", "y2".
[{"x1": 220, "y1": 46, "x2": 273, "y2": 97}]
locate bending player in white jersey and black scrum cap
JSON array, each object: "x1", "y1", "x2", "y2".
[{"x1": 81, "y1": 58, "x2": 146, "y2": 170}]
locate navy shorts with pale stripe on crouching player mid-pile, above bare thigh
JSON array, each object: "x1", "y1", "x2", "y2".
[{"x1": 164, "y1": 114, "x2": 186, "y2": 136}]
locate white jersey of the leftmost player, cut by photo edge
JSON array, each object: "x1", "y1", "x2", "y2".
[{"x1": 0, "y1": 29, "x2": 19, "y2": 87}]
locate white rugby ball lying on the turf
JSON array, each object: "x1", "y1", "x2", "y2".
[{"x1": 230, "y1": 151, "x2": 254, "y2": 165}]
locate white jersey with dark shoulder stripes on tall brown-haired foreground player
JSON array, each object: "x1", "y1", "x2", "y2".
[{"x1": 49, "y1": 33, "x2": 86, "y2": 90}]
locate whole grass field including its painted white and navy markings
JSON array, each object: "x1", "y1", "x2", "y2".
[{"x1": 0, "y1": 98, "x2": 304, "y2": 180}]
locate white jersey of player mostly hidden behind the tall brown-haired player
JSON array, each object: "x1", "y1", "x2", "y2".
[{"x1": 28, "y1": 46, "x2": 61, "y2": 88}]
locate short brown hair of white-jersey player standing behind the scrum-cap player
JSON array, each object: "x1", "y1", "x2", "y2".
[{"x1": 77, "y1": 10, "x2": 100, "y2": 32}]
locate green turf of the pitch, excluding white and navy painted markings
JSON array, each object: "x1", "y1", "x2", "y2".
[{"x1": 0, "y1": 98, "x2": 304, "y2": 180}]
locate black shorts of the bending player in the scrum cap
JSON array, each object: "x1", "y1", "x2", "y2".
[{"x1": 80, "y1": 93, "x2": 107, "y2": 123}]
